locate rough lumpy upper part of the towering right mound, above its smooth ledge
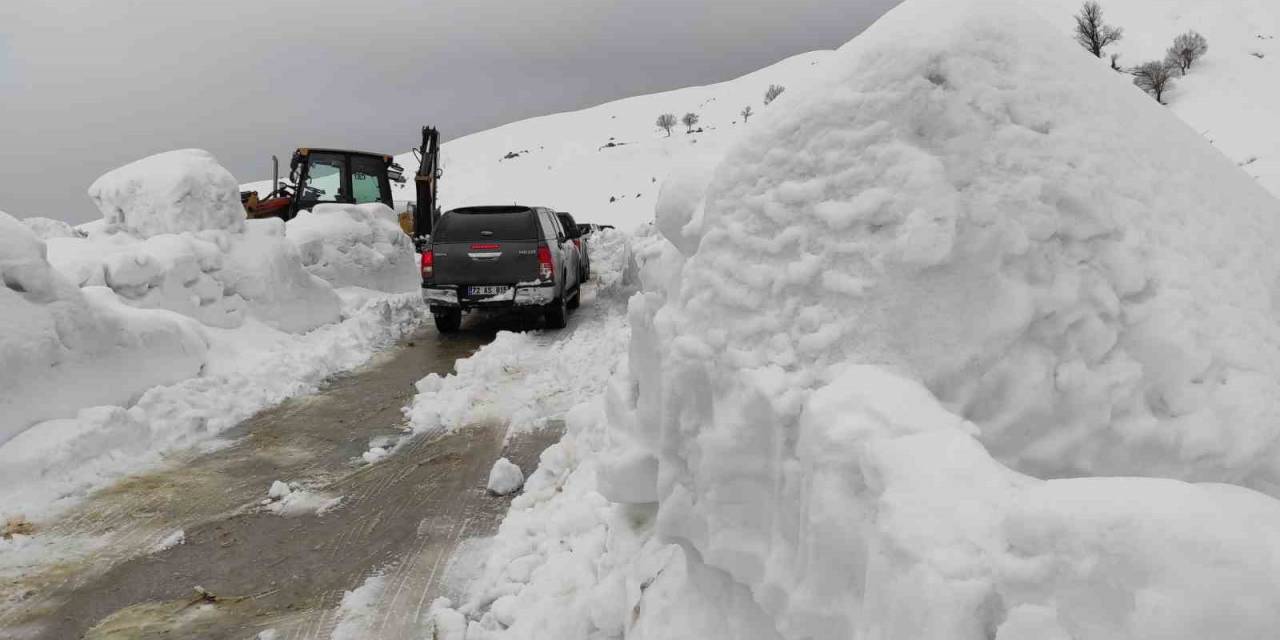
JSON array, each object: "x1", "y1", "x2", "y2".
[{"x1": 659, "y1": 4, "x2": 1280, "y2": 486}]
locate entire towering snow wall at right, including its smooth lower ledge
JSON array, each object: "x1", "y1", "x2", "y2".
[{"x1": 599, "y1": 0, "x2": 1280, "y2": 640}]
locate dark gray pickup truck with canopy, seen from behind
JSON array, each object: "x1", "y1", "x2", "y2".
[{"x1": 422, "y1": 205, "x2": 581, "y2": 333}]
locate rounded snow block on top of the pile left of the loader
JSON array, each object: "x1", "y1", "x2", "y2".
[{"x1": 88, "y1": 148, "x2": 244, "y2": 237}]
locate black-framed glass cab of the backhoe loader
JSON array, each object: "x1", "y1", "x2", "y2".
[{"x1": 283, "y1": 148, "x2": 404, "y2": 220}]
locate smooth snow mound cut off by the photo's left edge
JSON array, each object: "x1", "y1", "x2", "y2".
[{"x1": 0, "y1": 214, "x2": 207, "y2": 443}]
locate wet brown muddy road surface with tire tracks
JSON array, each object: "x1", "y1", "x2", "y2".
[{"x1": 0, "y1": 312, "x2": 568, "y2": 640}]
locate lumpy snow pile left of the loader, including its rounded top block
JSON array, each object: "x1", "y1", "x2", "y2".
[{"x1": 50, "y1": 150, "x2": 343, "y2": 333}]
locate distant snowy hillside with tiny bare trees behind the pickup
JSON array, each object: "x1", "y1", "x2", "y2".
[{"x1": 396, "y1": 51, "x2": 831, "y2": 228}]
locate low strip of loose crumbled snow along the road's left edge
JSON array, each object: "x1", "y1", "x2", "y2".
[{"x1": 0, "y1": 289, "x2": 424, "y2": 518}]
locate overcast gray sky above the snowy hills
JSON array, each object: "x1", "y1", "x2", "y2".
[{"x1": 0, "y1": 0, "x2": 897, "y2": 223}]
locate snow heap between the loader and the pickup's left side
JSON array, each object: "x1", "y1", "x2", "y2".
[{"x1": 287, "y1": 202, "x2": 422, "y2": 293}]
